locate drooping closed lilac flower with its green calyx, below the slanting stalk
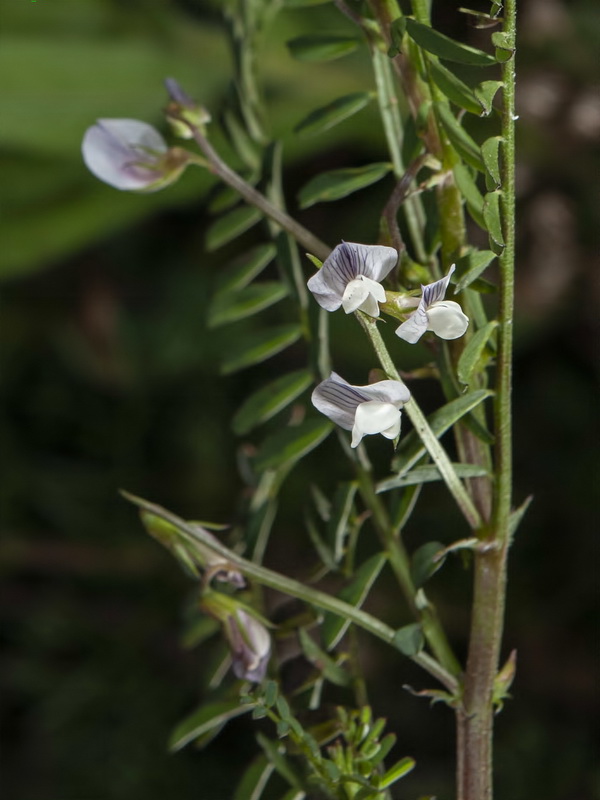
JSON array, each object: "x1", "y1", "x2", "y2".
[{"x1": 200, "y1": 592, "x2": 271, "y2": 683}]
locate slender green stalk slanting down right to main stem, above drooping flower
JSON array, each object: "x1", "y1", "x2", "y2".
[{"x1": 121, "y1": 492, "x2": 458, "y2": 693}]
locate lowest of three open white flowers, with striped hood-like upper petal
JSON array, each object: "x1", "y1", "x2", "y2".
[{"x1": 312, "y1": 372, "x2": 410, "y2": 447}]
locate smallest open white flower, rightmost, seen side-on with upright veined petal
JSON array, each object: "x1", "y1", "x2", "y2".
[{"x1": 396, "y1": 264, "x2": 469, "y2": 344}]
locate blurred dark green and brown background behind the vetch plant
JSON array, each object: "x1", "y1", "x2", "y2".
[{"x1": 0, "y1": 0, "x2": 600, "y2": 800}]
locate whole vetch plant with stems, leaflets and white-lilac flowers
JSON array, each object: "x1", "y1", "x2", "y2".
[{"x1": 83, "y1": 0, "x2": 527, "y2": 800}]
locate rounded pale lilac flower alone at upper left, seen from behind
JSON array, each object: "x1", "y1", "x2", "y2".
[{"x1": 81, "y1": 119, "x2": 189, "y2": 192}]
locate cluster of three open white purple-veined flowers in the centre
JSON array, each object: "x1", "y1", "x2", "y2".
[{"x1": 308, "y1": 242, "x2": 469, "y2": 447}]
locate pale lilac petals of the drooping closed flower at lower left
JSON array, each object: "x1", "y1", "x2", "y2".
[{"x1": 223, "y1": 608, "x2": 271, "y2": 683}]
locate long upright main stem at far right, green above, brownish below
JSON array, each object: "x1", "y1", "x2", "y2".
[{"x1": 457, "y1": 0, "x2": 516, "y2": 800}]
